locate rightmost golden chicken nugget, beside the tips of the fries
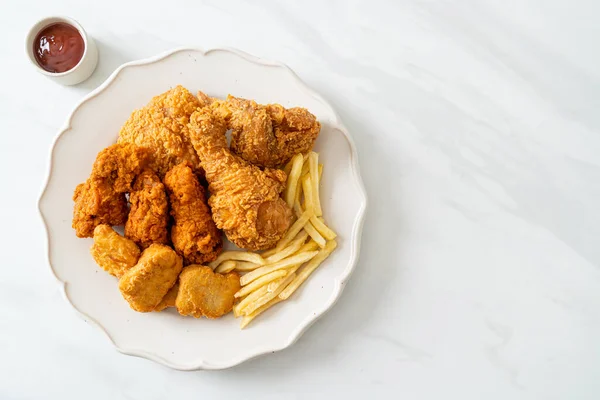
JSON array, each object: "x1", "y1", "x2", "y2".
[{"x1": 176, "y1": 265, "x2": 241, "y2": 318}]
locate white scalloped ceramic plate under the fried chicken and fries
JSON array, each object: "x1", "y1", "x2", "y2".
[{"x1": 39, "y1": 49, "x2": 367, "y2": 370}]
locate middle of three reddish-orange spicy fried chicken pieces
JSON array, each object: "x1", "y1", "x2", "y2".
[{"x1": 125, "y1": 170, "x2": 169, "y2": 249}]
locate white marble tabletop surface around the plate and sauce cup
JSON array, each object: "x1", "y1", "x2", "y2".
[{"x1": 0, "y1": 0, "x2": 600, "y2": 399}]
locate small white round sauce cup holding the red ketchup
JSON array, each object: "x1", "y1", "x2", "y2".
[{"x1": 25, "y1": 17, "x2": 98, "y2": 85}]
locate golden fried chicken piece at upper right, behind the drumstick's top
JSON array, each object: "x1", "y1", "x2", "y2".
[{"x1": 205, "y1": 93, "x2": 321, "y2": 168}]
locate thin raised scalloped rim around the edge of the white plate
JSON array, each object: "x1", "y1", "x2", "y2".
[{"x1": 37, "y1": 47, "x2": 368, "y2": 371}]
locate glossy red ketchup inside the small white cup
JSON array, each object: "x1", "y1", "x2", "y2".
[{"x1": 33, "y1": 22, "x2": 85, "y2": 73}]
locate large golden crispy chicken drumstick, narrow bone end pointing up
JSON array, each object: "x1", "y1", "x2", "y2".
[{"x1": 190, "y1": 107, "x2": 292, "y2": 250}]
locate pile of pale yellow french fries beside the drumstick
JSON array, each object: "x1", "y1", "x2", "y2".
[{"x1": 209, "y1": 152, "x2": 337, "y2": 329}]
